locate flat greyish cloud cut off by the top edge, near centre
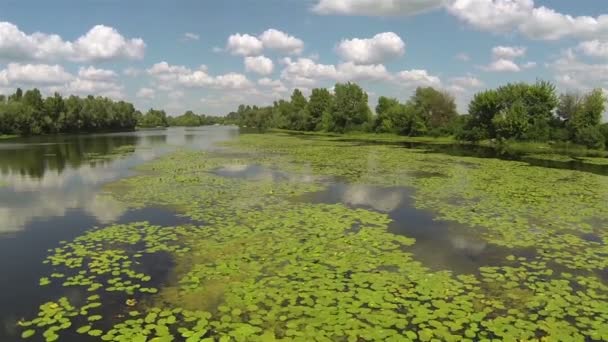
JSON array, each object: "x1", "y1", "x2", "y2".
[{"x1": 313, "y1": 0, "x2": 445, "y2": 16}]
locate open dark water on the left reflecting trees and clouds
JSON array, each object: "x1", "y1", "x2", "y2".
[{"x1": 0, "y1": 127, "x2": 238, "y2": 342}]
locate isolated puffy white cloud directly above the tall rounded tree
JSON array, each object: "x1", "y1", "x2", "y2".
[{"x1": 336, "y1": 32, "x2": 405, "y2": 64}]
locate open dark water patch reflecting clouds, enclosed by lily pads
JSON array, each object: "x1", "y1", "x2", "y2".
[{"x1": 303, "y1": 182, "x2": 514, "y2": 274}]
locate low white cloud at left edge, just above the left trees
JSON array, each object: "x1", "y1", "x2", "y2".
[{"x1": 0, "y1": 63, "x2": 74, "y2": 86}]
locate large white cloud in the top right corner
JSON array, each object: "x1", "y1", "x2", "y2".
[{"x1": 448, "y1": 0, "x2": 608, "y2": 40}]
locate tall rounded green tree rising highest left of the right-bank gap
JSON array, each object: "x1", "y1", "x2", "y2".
[{"x1": 324, "y1": 82, "x2": 371, "y2": 132}]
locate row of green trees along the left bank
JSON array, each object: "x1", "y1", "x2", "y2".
[{"x1": 0, "y1": 88, "x2": 225, "y2": 135}]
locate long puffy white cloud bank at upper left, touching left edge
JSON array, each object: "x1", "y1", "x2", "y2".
[{"x1": 0, "y1": 22, "x2": 146, "y2": 62}]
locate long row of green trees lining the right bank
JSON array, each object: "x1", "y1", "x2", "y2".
[{"x1": 226, "y1": 81, "x2": 608, "y2": 148}]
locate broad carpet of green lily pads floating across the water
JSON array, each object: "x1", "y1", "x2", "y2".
[{"x1": 20, "y1": 135, "x2": 608, "y2": 342}]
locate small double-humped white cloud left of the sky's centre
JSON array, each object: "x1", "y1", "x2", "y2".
[{"x1": 226, "y1": 29, "x2": 304, "y2": 56}]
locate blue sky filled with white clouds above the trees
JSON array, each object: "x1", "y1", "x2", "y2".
[{"x1": 0, "y1": 0, "x2": 608, "y2": 115}]
